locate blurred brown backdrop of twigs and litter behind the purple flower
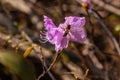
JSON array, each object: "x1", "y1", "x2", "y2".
[{"x1": 0, "y1": 0, "x2": 120, "y2": 80}]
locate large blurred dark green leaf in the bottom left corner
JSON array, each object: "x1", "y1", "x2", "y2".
[{"x1": 0, "y1": 50, "x2": 35, "y2": 80}]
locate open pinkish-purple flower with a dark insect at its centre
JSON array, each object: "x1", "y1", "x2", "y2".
[{"x1": 44, "y1": 16, "x2": 86, "y2": 52}]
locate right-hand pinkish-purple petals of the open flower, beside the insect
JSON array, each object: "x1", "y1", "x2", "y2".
[{"x1": 65, "y1": 16, "x2": 86, "y2": 42}]
